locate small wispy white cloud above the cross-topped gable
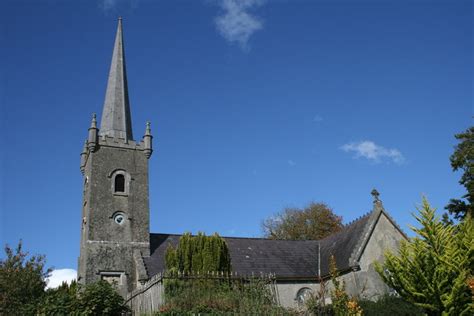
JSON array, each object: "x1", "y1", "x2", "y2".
[{"x1": 340, "y1": 140, "x2": 405, "y2": 164}]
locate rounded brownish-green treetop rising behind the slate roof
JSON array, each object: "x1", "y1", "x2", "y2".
[{"x1": 262, "y1": 203, "x2": 342, "y2": 240}]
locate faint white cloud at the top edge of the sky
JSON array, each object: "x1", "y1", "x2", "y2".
[{"x1": 214, "y1": 0, "x2": 265, "y2": 51}]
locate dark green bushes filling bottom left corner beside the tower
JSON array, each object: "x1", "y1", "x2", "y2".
[{"x1": 0, "y1": 241, "x2": 128, "y2": 315}]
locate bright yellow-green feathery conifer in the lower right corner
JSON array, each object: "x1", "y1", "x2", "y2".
[{"x1": 376, "y1": 199, "x2": 474, "y2": 315}]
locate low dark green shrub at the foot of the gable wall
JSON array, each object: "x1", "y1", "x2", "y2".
[{"x1": 359, "y1": 295, "x2": 424, "y2": 316}]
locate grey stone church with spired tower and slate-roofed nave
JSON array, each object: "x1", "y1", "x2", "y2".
[{"x1": 77, "y1": 19, "x2": 407, "y2": 313}]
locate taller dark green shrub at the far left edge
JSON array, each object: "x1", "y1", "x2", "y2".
[{"x1": 0, "y1": 240, "x2": 50, "y2": 315}]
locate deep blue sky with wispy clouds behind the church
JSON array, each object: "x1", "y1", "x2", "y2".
[{"x1": 0, "y1": 0, "x2": 473, "y2": 282}]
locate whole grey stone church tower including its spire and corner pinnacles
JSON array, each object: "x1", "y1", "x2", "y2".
[{"x1": 78, "y1": 19, "x2": 152, "y2": 296}]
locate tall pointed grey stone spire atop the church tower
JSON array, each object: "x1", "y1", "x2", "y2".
[{"x1": 99, "y1": 18, "x2": 133, "y2": 141}]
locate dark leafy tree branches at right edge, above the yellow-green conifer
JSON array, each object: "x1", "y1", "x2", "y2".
[{"x1": 443, "y1": 126, "x2": 474, "y2": 222}]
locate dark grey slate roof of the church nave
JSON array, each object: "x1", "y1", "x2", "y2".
[{"x1": 144, "y1": 207, "x2": 396, "y2": 280}]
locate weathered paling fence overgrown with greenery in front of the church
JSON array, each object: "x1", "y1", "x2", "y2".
[{"x1": 126, "y1": 272, "x2": 279, "y2": 315}]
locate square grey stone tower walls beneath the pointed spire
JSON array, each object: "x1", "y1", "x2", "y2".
[{"x1": 78, "y1": 137, "x2": 150, "y2": 297}]
